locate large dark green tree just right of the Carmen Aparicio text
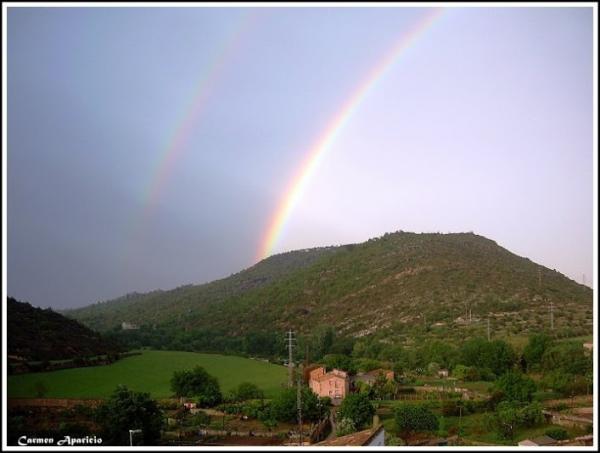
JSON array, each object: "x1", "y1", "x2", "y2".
[{"x1": 96, "y1": 385, "x2": 163, "y2": 445}]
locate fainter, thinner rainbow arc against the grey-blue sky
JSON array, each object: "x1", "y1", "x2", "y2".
[{"x1": 143, "y1": 9, "x2": 258, "y2": 216}]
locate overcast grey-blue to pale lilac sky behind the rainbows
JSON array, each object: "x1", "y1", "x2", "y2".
[{"x1": 7, "y1": 7, "x2": 594, "y2": 309}]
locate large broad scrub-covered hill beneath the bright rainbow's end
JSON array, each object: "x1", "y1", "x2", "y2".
[{"x1": 68, "y1": 232, "x2": 592, "y2": 342}]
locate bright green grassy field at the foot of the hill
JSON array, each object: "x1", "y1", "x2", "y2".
[{"x1": 8, "y1": 351, "x2": 287, "y2": 398}]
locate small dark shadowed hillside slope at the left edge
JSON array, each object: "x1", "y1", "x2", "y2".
[{"x1": 7, "y1": 297, "x2": 122, "y2": 361}]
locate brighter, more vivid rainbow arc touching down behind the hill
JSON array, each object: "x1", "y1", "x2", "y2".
[{"x1": 257, "y1": 8, "x2": 442, "y2": 261}]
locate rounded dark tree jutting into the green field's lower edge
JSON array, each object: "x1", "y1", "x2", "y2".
[{"x1": 171, "y1": 366, "x2": 223, "y2": 407}]
